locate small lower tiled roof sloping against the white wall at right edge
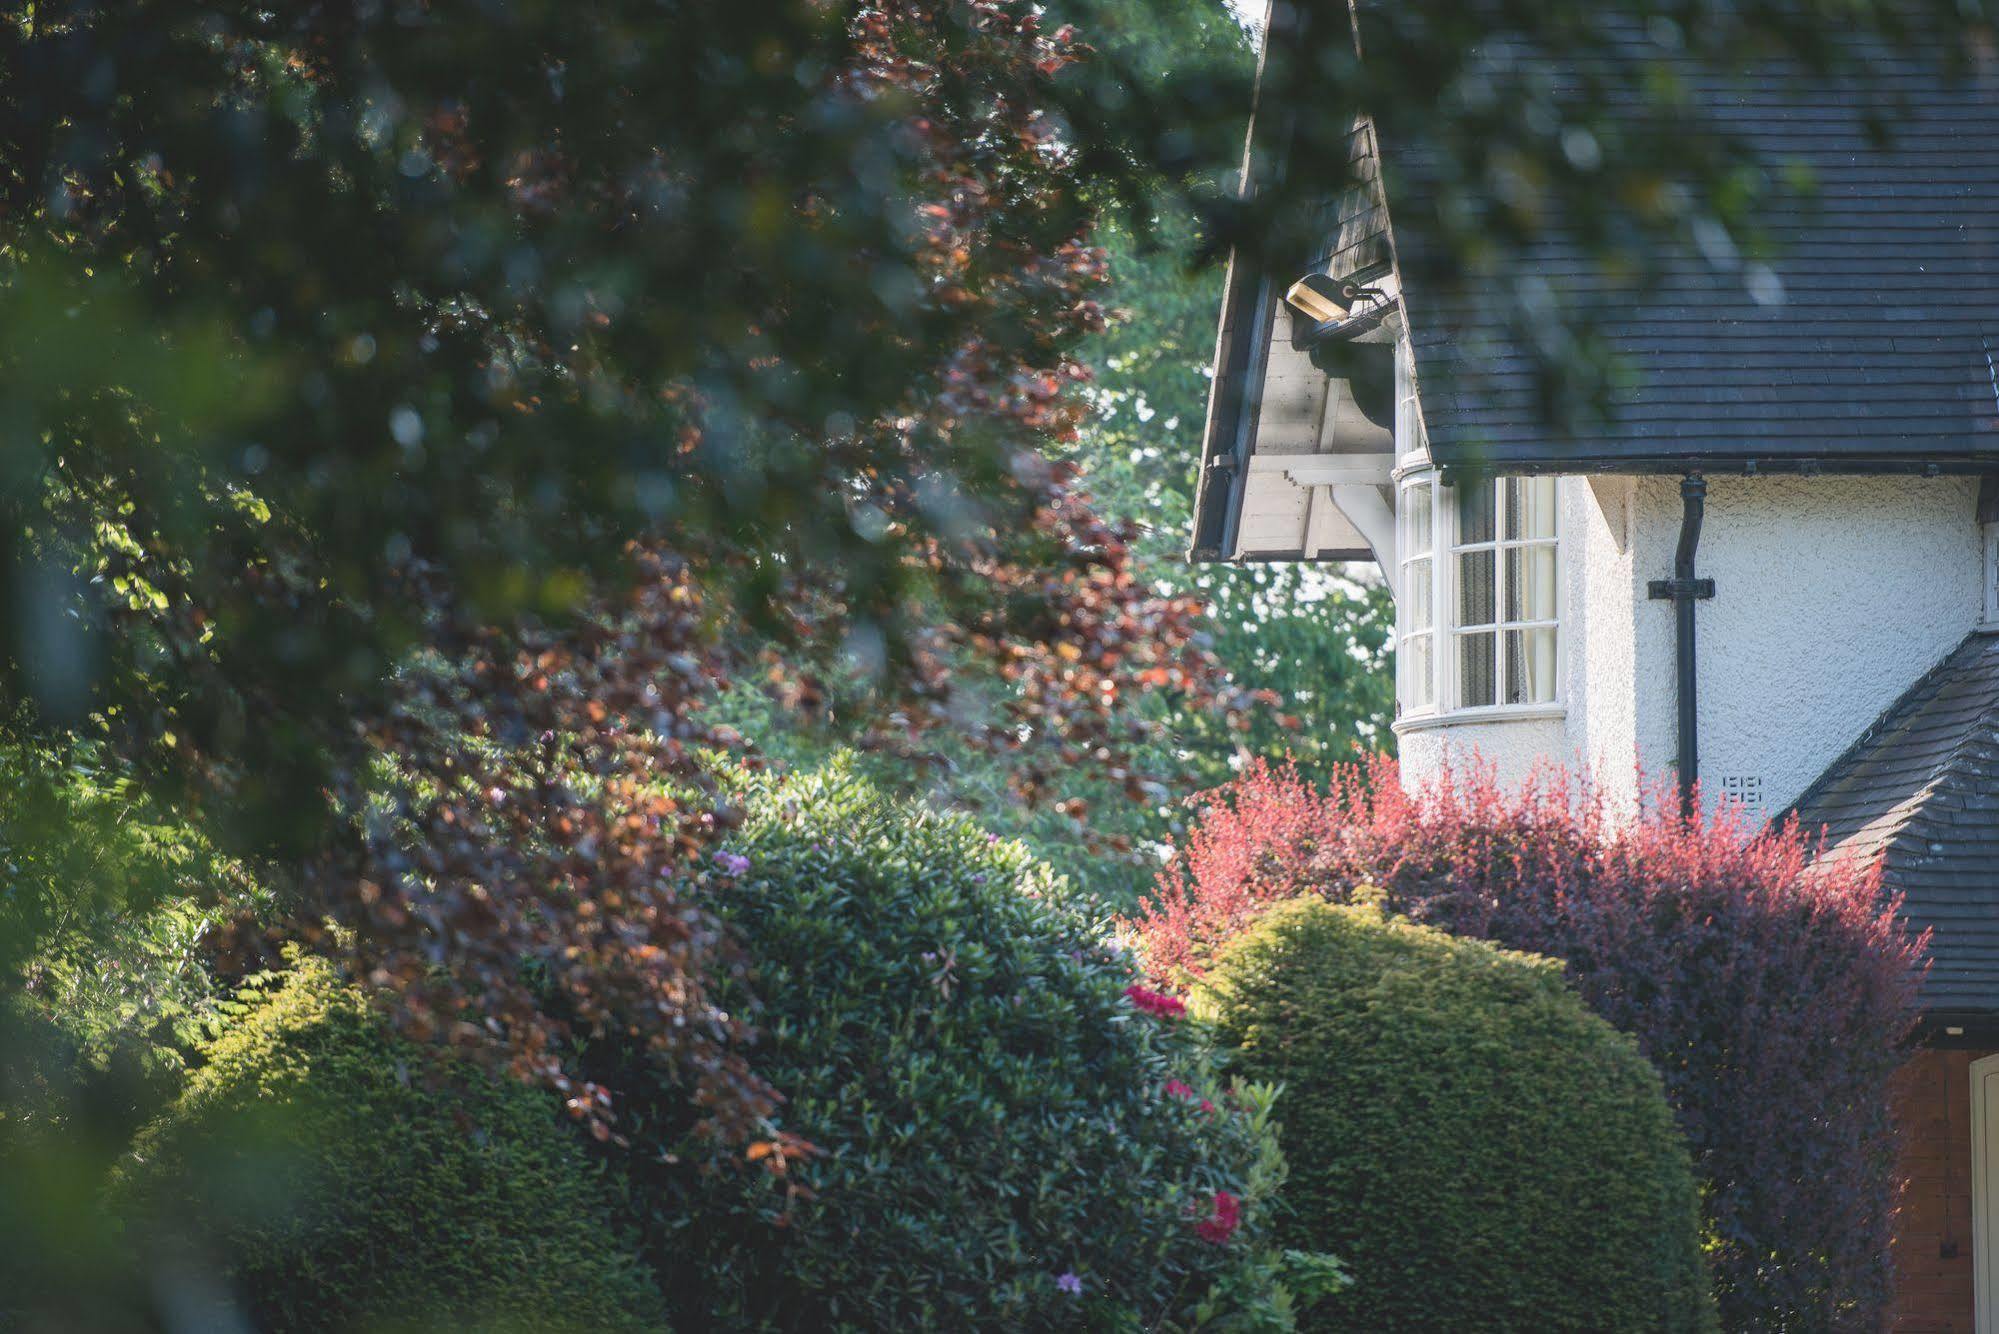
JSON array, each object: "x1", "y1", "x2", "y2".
[{"x1": 1793, "y1": 632, "x2": 1999, "y2": 1012}]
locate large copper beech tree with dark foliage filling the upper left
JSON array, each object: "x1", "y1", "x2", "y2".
[{"x1": 0, "y1": 0, "x2": 1243, "y2": 1164}]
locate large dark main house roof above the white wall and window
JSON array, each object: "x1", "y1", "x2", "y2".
[{"x1": 1383, "y1": 37, "x2": 1999, "y2": 472}]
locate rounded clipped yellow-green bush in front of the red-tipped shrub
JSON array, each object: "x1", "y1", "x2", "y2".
[{"x1": 1195, "y1": 900, "x2": 1715, "y2": 1332}]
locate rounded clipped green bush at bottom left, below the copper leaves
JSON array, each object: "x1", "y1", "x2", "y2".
[{"x1": 110, "y1": 958, "x2": 664, "y2": 1332}]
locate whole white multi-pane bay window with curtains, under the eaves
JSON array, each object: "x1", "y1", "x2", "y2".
[{"x1": 1397, "y1": 470, "x2": 1561, "y2": 718}]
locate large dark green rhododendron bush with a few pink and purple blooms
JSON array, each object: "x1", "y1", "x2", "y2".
[{"x1": 610, "y1": 764, "x2": 1309, "y2": 1330}]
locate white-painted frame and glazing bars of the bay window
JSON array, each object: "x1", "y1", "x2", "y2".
[{"x1": 1395, "y1": 464, "x2": 1567, "y2": 730}]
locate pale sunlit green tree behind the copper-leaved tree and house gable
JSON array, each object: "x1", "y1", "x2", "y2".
[{"x1": 732, "y1": 0, "x2": 1393, "y2": 906}]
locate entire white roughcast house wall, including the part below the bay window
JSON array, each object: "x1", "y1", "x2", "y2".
[{"x1": 1397, "y1": 476, "x2": 1983, "y2": 814}]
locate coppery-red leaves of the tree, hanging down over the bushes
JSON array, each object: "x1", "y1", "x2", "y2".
[{"x1": 171, "y1": 0, "x2": 1229, "y2": 1170}]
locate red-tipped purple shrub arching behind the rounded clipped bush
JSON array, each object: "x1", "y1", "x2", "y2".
[{"x1": 1129, "y1": 758, "x2": 1925, "y2": 1330}]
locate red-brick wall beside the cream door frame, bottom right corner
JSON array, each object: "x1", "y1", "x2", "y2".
[{"x1": 1889, "y1": 1050, "x2": 1985, "y2": 1334}]
